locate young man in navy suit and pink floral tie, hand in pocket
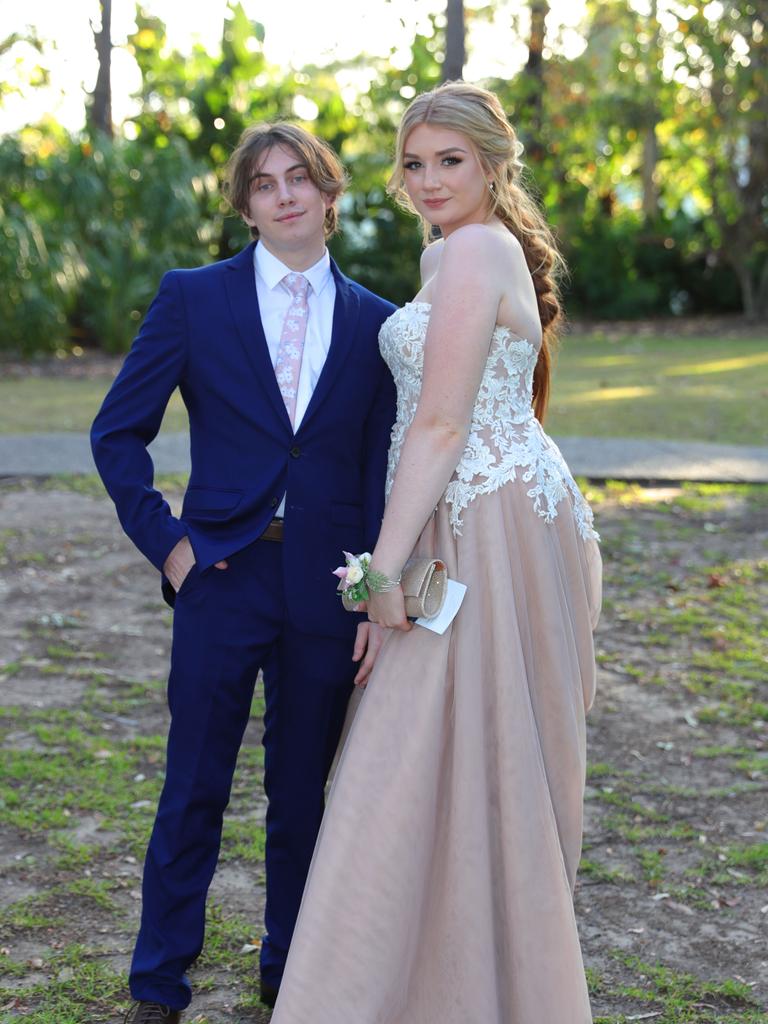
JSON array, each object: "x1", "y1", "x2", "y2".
[{"x1": 91, "y1": 123, "x2": 394, "y2": 1024}]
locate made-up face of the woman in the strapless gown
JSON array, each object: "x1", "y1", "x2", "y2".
[{"x1": 402, "y1": 124, "x2": 490, "y2": 237}]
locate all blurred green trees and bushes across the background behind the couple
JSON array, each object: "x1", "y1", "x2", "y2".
[{"x1": 0, "y1": 0, "x2": 768, "y2": 354}]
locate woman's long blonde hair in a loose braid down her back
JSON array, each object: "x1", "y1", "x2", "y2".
[{"x1": 387, "y1": 82, "x2": 565, "y2": 421}]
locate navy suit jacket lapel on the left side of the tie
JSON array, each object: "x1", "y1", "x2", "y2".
[{"x1": 224, "y1": 243, "x2": 294, "y2": 430}]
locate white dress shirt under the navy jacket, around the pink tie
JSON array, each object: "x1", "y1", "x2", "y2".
[{"x1": 253, "y1": 236, "x2": 336, "y2": 516}]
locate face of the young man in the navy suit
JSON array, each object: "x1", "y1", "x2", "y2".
[{"x1": 243, "y1": 145, "x2": 334, "y2": 259}]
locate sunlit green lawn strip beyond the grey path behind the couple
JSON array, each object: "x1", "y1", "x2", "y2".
[{"x1": 0, "y1": 334, "x2": 768, "y2": 444}]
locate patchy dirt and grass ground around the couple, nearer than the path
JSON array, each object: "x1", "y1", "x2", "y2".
[{"x1": 0, "y1": 481, "x2": 768, "y2": 1024}]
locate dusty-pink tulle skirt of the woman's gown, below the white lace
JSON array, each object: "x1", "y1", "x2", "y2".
[{"x1": 272, "y1": 478, "x2": 601, "y2": 1024}]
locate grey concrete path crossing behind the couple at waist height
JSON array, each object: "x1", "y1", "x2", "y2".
[{"x1": 0, "y1": 433, "x2": 768, "y2": 483}]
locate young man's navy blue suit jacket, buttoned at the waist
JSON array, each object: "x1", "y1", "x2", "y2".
[{"x1": 91, "y1": 244, "x2": 395, "y2": 636}]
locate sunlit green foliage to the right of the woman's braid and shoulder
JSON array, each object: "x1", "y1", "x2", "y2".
[{"x1": 489, "y1": 0, "x2": 757, "y2": 317}]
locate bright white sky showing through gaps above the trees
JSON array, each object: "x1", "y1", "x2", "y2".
[{"x1": 0, "y1": 0, "x2": 586, "y2": 132}]
